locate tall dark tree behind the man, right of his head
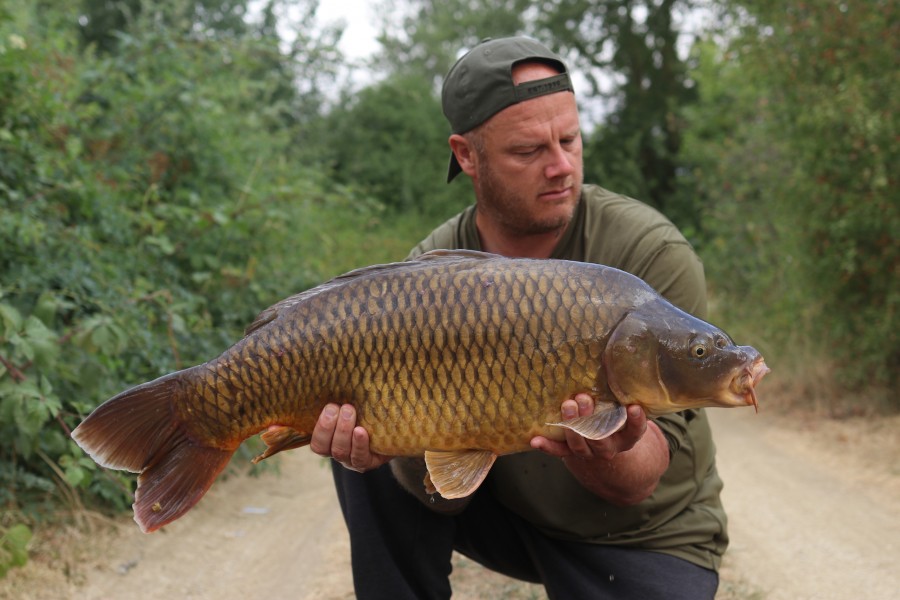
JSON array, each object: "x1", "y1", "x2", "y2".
[{"x1": 535, "y1": 0, "x2": 696, "y2": 226}]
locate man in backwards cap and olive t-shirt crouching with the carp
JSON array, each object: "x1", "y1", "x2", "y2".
[{"x1": 311, "y1": 38, "x2": 727, "y2": 600}]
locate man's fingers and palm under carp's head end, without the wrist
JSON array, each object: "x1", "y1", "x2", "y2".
[{"x1": 531, "y1": 394, "x2": 647, "y2": 460}]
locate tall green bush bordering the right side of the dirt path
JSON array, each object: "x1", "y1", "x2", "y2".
[{"x1": 685, "y1": 1, "x2": 900, "y2": 402}]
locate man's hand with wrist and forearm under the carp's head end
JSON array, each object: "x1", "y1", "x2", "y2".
[{"x1": 531, "y1": 394, "x2": 669, "y2": 506}]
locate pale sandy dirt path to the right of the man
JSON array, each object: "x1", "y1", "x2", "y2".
[{"x1": 710, "y1": 410, "x2": 900, "y2": 600}]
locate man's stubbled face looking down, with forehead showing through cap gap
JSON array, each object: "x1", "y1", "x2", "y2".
[{"x1": 464, "y1": 64, "x2": 583, "y2": 235}]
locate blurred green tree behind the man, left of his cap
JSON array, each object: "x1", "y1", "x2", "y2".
[{"x1": 324, "y1": 0, "x2": 527, "y2": 218}]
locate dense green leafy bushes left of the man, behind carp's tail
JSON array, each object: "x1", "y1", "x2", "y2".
[{"x1": 0, "y1": 0, "x2": 426, "y2": 572}]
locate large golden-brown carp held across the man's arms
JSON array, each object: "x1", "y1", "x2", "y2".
[{"x1": 72, "y1": 251, "x2": 768, "y2": 532}]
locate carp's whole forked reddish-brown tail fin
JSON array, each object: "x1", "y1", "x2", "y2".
[{"x1": 72, "y1": 367, "x2": 236, "y2": 533}]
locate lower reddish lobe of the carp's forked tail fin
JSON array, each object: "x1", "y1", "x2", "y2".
[{"x1": 133, "y1": 435, "x2": 234, "y2": 533}]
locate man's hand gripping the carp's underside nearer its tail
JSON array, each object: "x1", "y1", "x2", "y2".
[{"x1": 309, "y1": 404, "x2": 391, "y2": 473}]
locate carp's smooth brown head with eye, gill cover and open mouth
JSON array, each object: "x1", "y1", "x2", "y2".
[{"x1": 604, "y1": 305, "x2": 769, "y2": 416}]
